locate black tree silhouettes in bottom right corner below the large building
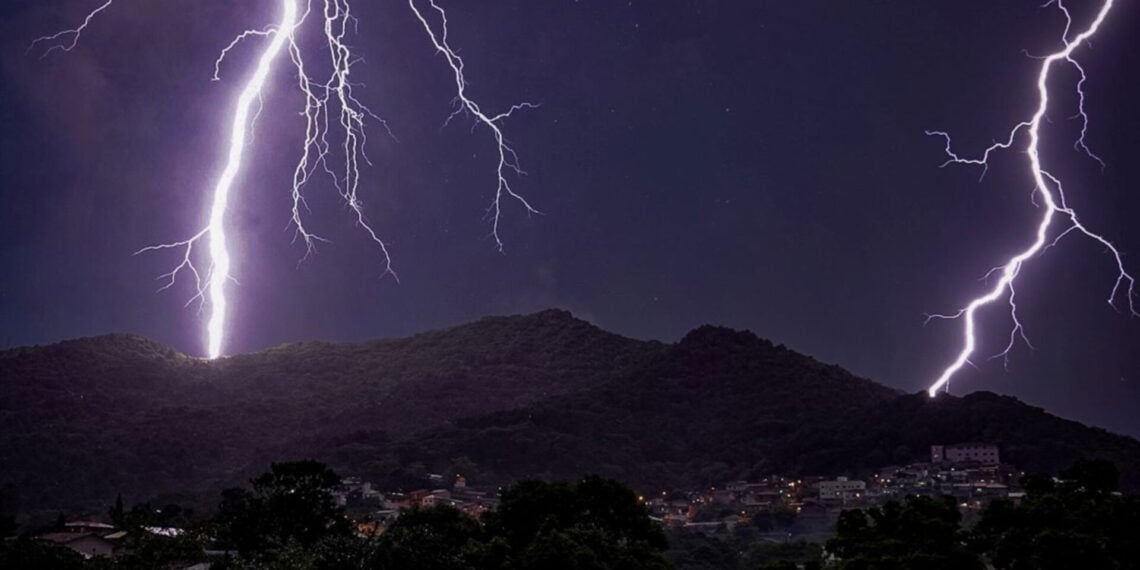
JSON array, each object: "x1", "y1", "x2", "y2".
[{"x1": 827, "y1": 461, "x2": 1140, "y2": 570}]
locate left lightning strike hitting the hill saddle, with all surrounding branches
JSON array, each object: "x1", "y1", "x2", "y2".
[{"x1": 29, "y1": 0, "x2": 539, "y2": 359}]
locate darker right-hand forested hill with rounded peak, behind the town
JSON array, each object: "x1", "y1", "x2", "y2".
[{"x1": 360, "y1": 327, "x2": 1140, "y2": 489}]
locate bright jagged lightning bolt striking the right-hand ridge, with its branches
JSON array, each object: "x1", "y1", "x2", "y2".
[{"x1": 927, "y1": 0, "x2": 1138, "y2": 398}]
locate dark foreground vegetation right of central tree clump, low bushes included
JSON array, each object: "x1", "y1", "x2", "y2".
[{"x1": 669, "y1": 461, "x2": 1140, "y2": 570}]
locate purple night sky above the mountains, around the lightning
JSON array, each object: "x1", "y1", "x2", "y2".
[{"x1": 0, "y1": 0, "x2": 1140, "y2": 435}]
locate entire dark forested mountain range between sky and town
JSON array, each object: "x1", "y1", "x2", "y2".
[{"x1": 0, "y1": 311, "x2": 1140, "y2": 516}]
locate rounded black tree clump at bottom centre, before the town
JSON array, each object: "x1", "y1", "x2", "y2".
[{"x1": 380, "y1": 477, "x2": 671, "y2": 570}]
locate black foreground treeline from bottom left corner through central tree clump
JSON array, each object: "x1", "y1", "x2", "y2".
[{"x1": 0, "y1": 461, "x2": 671, "y2": 570}]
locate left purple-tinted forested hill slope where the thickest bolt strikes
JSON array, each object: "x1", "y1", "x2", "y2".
[{"x1": 0, "y1": 311, "x2": 662, "y2": 508}]
